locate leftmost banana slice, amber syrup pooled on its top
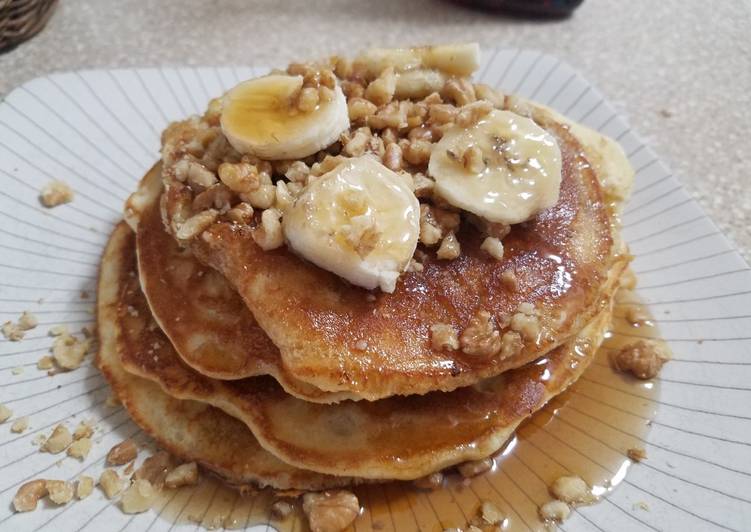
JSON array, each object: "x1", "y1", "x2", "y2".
[{"x1": 221, "y1": 74, "x2": 349, "y2": 160}]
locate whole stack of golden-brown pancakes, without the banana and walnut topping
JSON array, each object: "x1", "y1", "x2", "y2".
[{"x1": 98, "y1": 88, "x2": 633, "y2": 490}]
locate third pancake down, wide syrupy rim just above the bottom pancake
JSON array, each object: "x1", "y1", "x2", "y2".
[{"x1": 116, "y1": 220, "x2": 620, "y2": 480}]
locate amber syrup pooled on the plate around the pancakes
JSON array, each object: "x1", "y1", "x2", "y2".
[{"x1": 154, "y1": 284, "x2": 660, "y2": 532}]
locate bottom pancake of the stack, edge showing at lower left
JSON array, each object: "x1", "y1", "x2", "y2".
[{"x1": 96, "y1": 223, "x2": 356, "y2": 490}]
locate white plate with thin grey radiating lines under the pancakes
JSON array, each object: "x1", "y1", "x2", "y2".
[{"x1": 0, "y1": 50, "x2": 751, "y2": 531}]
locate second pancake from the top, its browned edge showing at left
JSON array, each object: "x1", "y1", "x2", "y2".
[{"x1": 132, "y1": 167, "x2": 357, "y2": 402}]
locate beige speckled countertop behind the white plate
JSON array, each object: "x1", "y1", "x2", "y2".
[{"x1": 0, "y1": 0, "x2": 751, "y2": 259}]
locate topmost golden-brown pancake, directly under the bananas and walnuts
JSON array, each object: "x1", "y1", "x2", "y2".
[{"x1": 164, "y1": 109, "x2": 620, "y2": 400}]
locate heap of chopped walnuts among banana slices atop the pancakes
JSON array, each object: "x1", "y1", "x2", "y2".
[{"x1": 156, "y1": 53, "x2": 516, "y2": 271}]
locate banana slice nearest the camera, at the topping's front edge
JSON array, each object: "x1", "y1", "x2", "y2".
[{"x1": 282, "y1": 155, "x2": 420, "y2": 293}]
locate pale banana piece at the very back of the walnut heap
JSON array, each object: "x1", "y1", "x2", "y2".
[{"x1": 355, "y1": 43, "x2": 480, "y2": 77}]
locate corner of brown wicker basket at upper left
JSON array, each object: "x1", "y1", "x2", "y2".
[{"x1": 0, "y1": 0, "x2": 57, "y2": 53}]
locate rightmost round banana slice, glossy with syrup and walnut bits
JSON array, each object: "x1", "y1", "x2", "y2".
[{"x1": 428, "y1": 111, "x2": 561, "y2": 225}]
